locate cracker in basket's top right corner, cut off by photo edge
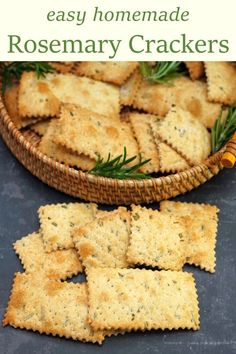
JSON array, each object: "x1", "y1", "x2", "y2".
[{"x1": 205, "y1": 61, "x2": 236, "y2": 105}]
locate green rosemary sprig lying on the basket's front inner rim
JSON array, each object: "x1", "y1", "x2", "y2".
[{"x1": 89, "y1": 147, "x2": 151, "y2": 179}]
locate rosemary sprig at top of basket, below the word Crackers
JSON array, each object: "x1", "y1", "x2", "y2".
[{"x1": 139, "y1": 61, "x2": 186, "y2": 84}]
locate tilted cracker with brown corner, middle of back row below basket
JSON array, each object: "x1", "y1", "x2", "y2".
[{"x1": 73, "y1": 208, "x2": 130, "y2": 270}]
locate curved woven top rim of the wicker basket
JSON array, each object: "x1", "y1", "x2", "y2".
[{"x1": 0, "y1": 87, "x2": 225, "y2": 188}]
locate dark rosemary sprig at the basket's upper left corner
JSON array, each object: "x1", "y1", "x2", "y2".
[{"x1": 0, "y1": 61, "x2": 54, "y2": 93}]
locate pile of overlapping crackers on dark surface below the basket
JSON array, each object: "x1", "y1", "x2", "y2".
[{"x1": 3, "y1": 201, "x2": 218, "y2": 343}]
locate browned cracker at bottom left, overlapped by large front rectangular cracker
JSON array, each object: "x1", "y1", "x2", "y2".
[{"x1": 3, "y1": 273, "x2": 104, "y2": 344}]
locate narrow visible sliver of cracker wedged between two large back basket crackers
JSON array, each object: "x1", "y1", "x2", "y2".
[{"x1": 120, "y1": 69, "x2": 142, "y2": 106}]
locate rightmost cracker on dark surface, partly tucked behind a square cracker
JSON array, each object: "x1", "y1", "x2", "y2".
[{"x1": 160, "y1": 201, "x2": 219, "y2": 273}]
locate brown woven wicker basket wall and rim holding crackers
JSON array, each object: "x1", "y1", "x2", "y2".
[{"x1": 0, "y1": 74, "x2": 233, "y2": 204}]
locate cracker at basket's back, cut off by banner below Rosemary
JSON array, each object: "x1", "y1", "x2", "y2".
[{"x1": 76, "y1": 61, "x2": 139, "y2": 85}]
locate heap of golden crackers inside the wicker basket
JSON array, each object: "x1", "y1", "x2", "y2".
[{"x1": 5, "y1": 62, "x2": 236, "y2": 173}]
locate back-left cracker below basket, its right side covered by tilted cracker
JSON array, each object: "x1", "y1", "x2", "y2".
[{"x1": 38, "y1": 203, "x2": 97, "y2": 252}]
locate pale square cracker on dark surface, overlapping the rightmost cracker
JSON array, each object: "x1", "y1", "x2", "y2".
[{"x1": 127, "y1": 205, "x2": 186, "y2": 270}]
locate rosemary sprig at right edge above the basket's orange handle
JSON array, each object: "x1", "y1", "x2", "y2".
[{"x1": 211, "y1": 107, "x2": 236, "y2": 153}]
